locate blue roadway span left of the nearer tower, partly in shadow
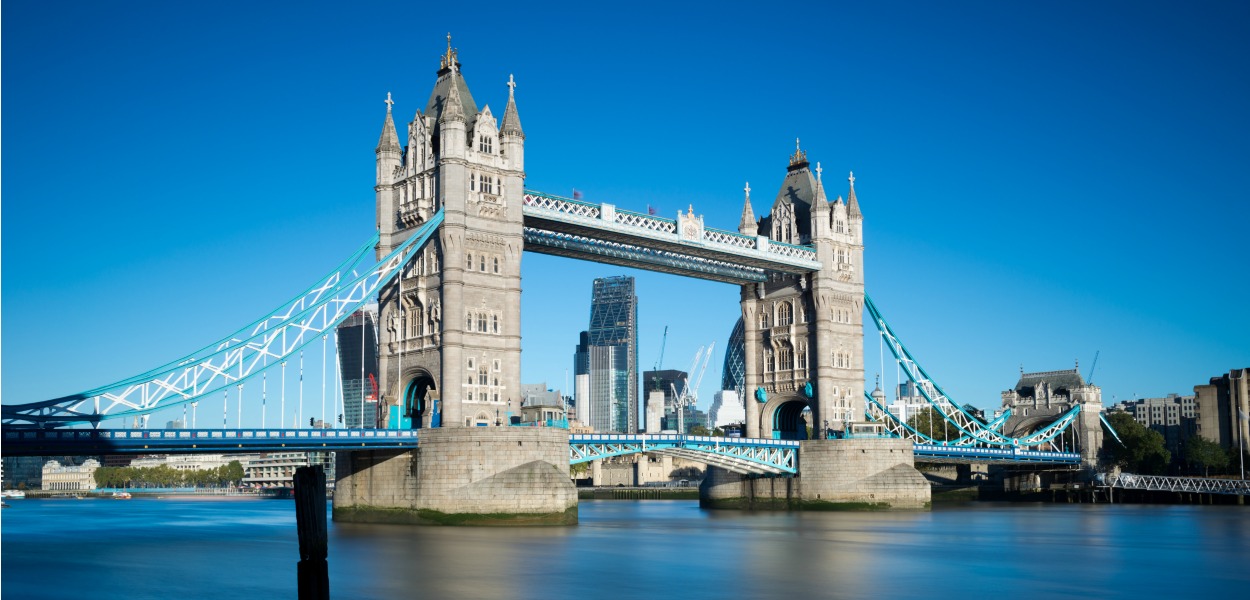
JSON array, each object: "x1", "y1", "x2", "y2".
[{"x1": 4, "y1": 429, "x2": 418, "y2": 456}]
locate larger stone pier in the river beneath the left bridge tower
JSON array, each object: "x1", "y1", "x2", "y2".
[{"x1": 334, "y1": 428, "x2": 578, "y2": 525}]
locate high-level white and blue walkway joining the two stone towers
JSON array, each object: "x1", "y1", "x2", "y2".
[{"x1": 521, "y1": 191, "x2": 820, "y2": 285}]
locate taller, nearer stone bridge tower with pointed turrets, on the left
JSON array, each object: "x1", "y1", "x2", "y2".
[{"x1": 375, "y1": 36, "x2": 525, "y2": 428}]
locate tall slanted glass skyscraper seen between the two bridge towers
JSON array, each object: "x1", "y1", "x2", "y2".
[{"x1": 574, "y1": 276, "x2": 639, "y2": 434}]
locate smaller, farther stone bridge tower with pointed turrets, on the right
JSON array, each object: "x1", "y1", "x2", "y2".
[{"x1": 739, "y1": 143, "x2": 864, "y2": 439}]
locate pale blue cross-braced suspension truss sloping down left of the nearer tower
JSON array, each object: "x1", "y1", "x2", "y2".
[{"x1": 3, "y1": 210, "x2": 443, "y2": 428}]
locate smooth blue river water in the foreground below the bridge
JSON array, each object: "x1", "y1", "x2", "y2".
[{"x1": 0, "y1": 499, "x2": 1250, "y2": 600}]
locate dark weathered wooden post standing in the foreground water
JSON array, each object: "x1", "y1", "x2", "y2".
[{"x1": 295, "y1": 465, "x2": 330, "y2": 600}]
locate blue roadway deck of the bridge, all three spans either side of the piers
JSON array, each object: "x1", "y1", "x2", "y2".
[{"x1": 3, "y1": 429, "x2": 1080, "y2": 475}]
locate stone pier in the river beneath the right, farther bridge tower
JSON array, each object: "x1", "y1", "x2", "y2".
[{"x1": 699, "y1": 438, "x2": 930, "y2": 510}]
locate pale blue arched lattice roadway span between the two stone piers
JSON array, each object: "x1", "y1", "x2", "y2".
[{"x1": 569, "y1": 434, "x2": 799, "y2": 475}]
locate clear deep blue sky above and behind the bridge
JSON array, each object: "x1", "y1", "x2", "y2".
[{"x1": 0, "y1": 1, "x2": 1250, "y2": 427}]
